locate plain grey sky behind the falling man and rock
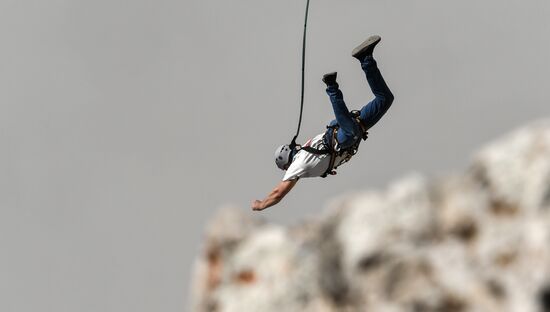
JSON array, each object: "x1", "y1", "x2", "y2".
[{"x1": 0, "y1": 0, "x2": 550, "y2": 312}]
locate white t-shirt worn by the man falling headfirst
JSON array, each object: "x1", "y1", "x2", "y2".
[{"x1": 283, "y1": 133, "x2": 350, "y2": 181}]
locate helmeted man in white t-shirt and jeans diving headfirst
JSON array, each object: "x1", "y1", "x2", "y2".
[{"x1": 252, "y1": 36, "x2": 393, "y2": 211}]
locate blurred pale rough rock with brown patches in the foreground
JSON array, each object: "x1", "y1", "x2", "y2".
[{"x1": 193, "y1": 120, "x2": 550, "y2": 312}]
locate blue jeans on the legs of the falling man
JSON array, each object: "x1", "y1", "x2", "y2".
[{"x1": 327, "y1": 57, "x2": 393, "y2": 149}]
